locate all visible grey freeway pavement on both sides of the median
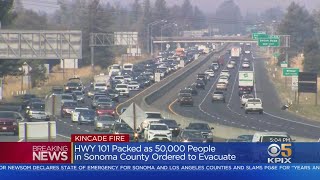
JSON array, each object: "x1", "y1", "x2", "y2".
[{"x1": 0, "y1": 43, "x2": 320, "y2": 141}]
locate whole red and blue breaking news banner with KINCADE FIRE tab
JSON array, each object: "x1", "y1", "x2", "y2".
[{"x1": 0, "y1": 134, "x2": 320, "y2": 166}]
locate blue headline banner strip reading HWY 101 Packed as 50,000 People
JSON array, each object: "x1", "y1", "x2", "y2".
[{"x1": 73, "y1": 143, "x2": 320, "y2": 165}]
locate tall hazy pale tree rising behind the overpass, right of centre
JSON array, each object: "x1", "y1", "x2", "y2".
[{"x1": 211, "y1": 0, "x2": 244, "y2": 34}]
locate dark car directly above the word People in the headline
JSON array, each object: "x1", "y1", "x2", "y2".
[{"x1": 177, "y1": 129, "x2": 207, "y2": 143}]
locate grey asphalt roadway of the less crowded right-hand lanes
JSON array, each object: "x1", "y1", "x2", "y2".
[{"x1": 161, "y1": 46, "x2": 320, "y2": 139}]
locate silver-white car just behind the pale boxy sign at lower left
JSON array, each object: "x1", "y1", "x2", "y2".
[{"x1": 26, "y1": 102, "x2": 50, "y2": 121}]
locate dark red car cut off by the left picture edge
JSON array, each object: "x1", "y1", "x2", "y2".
[{"x1": 0, "y1": 111, "x2": 24, "y2": 135}]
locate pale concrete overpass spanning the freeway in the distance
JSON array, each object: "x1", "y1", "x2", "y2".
[{"x1": 152, "y1": 36, "x2": 257, "y2": 44}]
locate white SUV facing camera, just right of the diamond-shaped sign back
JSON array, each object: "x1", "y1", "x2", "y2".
[{"x1": 144, "y1": 123, "x2": 172, "y2": 142}]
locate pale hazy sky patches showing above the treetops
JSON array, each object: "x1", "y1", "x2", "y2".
[{"x1": 21, "y1": 0, "x2": 320, "y2": 14}]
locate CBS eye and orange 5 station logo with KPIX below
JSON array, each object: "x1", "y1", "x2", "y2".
[{"x1": 268, "y1": 144, "x2": 292, "y2": 163}]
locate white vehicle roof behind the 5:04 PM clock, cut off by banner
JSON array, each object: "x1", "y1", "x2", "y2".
[{"x1": 252, "y1": 132, "x2": 292, "y2": 143}]
